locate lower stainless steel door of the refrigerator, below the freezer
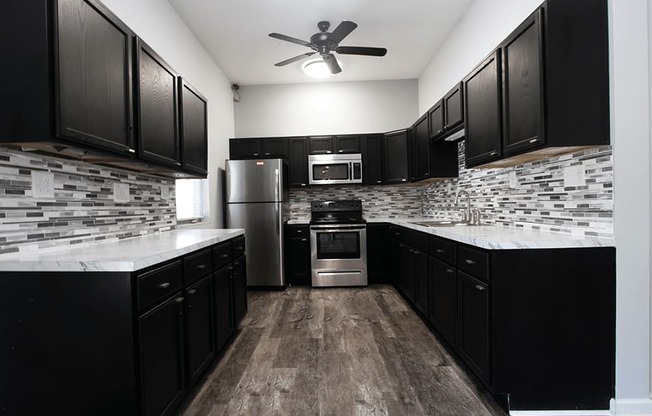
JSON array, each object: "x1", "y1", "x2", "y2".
[{"x1": 226, "y1": 203, "x2": 285, "y2": 286}]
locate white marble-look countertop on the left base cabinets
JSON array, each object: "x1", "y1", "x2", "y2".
[{"x1": 0, "y1": 229, "x2": 244, "y2": 272}]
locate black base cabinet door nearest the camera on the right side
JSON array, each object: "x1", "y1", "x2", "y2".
[{"x1": 457, "y1": 271, "x2": 489, "y2": 382}]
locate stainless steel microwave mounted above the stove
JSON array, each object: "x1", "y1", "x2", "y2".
[{"x1": 308, "y1": 153, "x2": 362, "y2": 185}]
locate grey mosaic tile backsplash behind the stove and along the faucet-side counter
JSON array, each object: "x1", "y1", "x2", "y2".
[{"x1": 290, "y1": 141, "x2": 613, "y2": 238}]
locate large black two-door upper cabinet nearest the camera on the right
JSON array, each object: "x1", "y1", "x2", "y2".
[{"x1": 464, "y1": 0, "x2": 609, "y2": 167}]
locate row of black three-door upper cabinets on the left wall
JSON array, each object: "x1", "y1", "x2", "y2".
[{"x1": 0, "y1": 0, "x2": 206, "y2": 176}]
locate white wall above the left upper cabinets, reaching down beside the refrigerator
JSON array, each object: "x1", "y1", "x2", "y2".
[{"x1": 102, "y1": 0, "x2": 234, "y2": 228}]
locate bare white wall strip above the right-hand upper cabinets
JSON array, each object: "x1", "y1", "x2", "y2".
[{"x1": 419, "y1": 0, "x2": 543, "y2": 114}]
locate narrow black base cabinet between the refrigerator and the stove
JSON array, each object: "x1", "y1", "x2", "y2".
[{"x1": 285, "y1": 224, "x2": 312, "y2": 286}]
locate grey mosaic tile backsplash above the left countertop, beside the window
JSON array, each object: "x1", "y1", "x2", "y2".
[{"x1": 0, "y1": 147, "x2": 176, "y2": 254}]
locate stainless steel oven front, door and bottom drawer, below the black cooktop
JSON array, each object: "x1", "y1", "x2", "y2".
[{"x1": 310, "y1": 224, "x2": 367, "y2": 287}]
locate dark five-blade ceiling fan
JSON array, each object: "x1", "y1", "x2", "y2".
[{"x1": 269, "y1": 20, "x2": 387, "y2": 74}]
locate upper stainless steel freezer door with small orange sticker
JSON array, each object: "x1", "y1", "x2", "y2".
[{"x1": 226, "y1": 159, "x2": 283, "y2": 203}]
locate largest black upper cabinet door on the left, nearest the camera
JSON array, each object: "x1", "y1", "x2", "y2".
[{"x1": 55, "y1": 0, "x2": 134, "y2": 153}]
